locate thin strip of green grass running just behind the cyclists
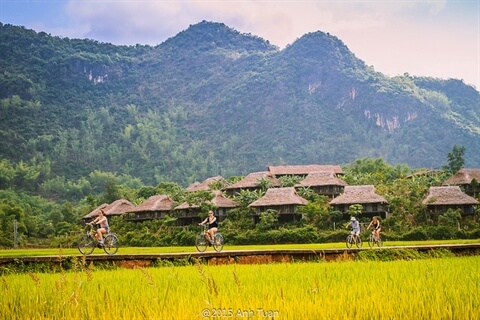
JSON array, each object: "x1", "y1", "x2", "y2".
[{"x1": 0, "y1": 239, "x2": 479, "y2": 257}]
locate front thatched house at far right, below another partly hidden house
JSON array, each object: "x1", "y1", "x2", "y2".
[{"x1": 422, "y1": 186, "x2": 479, "y2": 219}]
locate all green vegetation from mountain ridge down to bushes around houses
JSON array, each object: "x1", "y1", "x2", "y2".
[{"x1": 0, "y1": 22, "x2": 480, "y2": 247}]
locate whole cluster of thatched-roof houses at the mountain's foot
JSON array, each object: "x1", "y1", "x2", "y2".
[{"x1": 84, "y1": 165, "x2": 480, "y2": 226}]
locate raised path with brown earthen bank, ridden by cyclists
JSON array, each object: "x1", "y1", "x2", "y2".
[{"x1": 0, "y1": 243, "x2": 480, "y2": 269}]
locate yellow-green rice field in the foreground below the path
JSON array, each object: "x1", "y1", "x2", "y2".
[{"x1": 0, "y1": 256, "x2": 480, "y2": 319}]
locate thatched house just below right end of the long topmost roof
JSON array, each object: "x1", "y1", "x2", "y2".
[{"x1": 295, "y1": 171, "x2": 347, "y2": 200}]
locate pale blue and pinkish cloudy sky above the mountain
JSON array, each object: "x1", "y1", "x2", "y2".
[{"x1": 0, "y1": 0, "x2": 480, "y2": 90}]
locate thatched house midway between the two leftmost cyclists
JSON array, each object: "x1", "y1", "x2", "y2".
[{"x1": 124, "y1": 194, "x2": 173, "y2": 221}]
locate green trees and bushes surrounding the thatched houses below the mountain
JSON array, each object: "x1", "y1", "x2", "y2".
[{"x1": 0, "y1": 146, "x2": 480, "y2": 248}]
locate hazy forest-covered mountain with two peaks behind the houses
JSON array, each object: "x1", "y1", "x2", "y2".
[{"x1": 0, "y1": 21, "x2": 480, "y2": 185}]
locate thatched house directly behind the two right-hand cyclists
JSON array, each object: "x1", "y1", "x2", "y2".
[{"x1": 330, "y1": 185, "x2": 388, "y2": 218}]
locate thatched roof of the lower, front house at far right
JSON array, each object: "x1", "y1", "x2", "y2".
[{"x1": 422, "y1": 186, "x2": 479, "y2": 206}]
